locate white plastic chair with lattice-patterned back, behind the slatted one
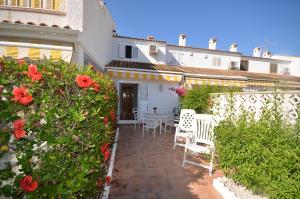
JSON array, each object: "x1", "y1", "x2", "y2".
[{"x1": 174, "y1": 109, "x2": 195, "y2": 149}]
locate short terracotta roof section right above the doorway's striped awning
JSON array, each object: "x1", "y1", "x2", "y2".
[{"x1": 106, "y1": 60, "x2": 183, "y2": 72}]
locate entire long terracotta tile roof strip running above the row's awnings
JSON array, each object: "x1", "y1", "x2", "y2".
[{"x1": 106, "y1": 60, "x2": 300, "y2": 82}]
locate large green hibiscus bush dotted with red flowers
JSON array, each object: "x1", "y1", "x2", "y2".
[{"x1": 0, "y1": 60, "x2": 117, "y2": 199}]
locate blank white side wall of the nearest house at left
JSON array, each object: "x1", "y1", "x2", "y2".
[{"x1": 79, "y1": 0, "x2": 115, "y2": 69}]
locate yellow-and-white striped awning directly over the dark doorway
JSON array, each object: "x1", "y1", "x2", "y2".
[{"x1": 107, "y1": 69, "x2": 182, "y2": 82}]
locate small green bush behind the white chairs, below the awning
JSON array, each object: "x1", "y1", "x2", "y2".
[{"x1": 181, "y1": 85, "x2": 241, "y2": 113}]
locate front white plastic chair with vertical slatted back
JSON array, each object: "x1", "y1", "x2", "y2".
[{"x1": 182, "y1": 114, "x2": 217, "y2": 175}]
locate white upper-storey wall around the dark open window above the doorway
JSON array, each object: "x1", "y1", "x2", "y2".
[{"x1": 113, "y1": 37, "x2": 166, "y2": 64}]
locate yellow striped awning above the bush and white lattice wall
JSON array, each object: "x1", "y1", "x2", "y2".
[{"x1": 186, "y1": 78, "x2": 247, "y2": 87}]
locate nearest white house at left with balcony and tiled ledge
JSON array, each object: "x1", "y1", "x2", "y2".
[{"x1": 0, "y1": 0, "x2": 115, "y2": 71}]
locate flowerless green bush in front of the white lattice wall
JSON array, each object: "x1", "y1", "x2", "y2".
[{"x1": 215, "y1": 96, "x2": 300, "y2": 199}]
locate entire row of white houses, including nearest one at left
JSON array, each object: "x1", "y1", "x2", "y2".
[{"x1": 0, "y1": 0, "x2": 300, "y2": 121}]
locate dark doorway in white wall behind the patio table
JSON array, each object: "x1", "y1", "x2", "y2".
[{"x1": 120, "y1": 84, "x2": 138, "y2": 120}]
